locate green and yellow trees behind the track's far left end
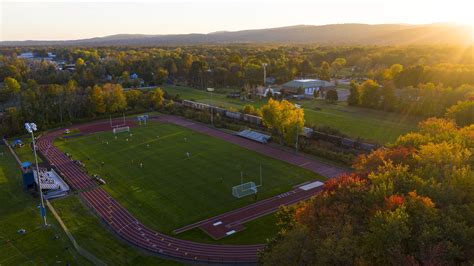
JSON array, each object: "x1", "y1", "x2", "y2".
[{"x1": 0, "y1": 79, "x2": 165, "y2": 136}]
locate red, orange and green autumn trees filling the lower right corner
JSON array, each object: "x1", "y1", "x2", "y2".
[{"x1": 261, "y1": 118, "x2": 474, "y2": 265}]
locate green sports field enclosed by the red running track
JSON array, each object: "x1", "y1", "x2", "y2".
[{"x1": 56, "y1": 123, "x2": 321, "y2": 243}]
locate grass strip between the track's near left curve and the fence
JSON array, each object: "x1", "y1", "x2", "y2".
[{"x1": 52, "y1": 196, "x2": 180, "y2": 265}]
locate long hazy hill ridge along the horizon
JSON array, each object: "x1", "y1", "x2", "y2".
[{"x1": 0, "y1": 24, "x2": 473, "y2": 46}]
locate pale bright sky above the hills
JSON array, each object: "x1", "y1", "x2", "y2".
[{"x1": 0, "y1": 0, "x2": 474, "y2": 41}]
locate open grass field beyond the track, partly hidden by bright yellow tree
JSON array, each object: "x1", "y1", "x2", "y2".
[{"x1": 163, "y1": 86, "x2": 421, "y2": 144}]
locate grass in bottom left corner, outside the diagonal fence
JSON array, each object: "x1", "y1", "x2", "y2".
[{"x1": 0, "y1": 145, "x2": 89, "y2": 265}]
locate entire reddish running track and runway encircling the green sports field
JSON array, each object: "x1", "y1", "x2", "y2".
[{"x1": 37, "y1": 116, "x2": 343, "y2": 264}]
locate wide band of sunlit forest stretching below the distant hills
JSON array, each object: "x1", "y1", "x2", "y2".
[{"x1": 0, "y1": 45, "x2": 474, "y2": 87}]
